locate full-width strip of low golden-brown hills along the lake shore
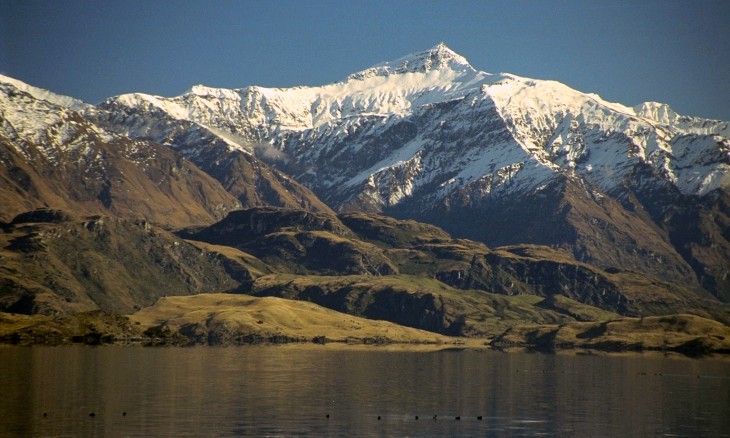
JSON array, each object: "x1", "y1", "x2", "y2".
[{"x1": 0, "y1": 306, "x2": 730, "y2": 357}]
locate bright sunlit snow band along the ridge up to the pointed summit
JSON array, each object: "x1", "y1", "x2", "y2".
[{"x1": 92, "y1": 45, "x2": 498, "y2": 144}]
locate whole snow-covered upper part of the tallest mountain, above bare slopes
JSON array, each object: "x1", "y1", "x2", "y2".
[{"x1": 91, "y1": 44, "x2": 729, "y2": 210}]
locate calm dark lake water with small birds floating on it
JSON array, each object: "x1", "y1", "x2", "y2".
[{"x1": 0, "y1": 346, "x2": 730, "y2": 437}]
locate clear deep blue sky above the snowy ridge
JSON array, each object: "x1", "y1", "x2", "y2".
[{"x1": 0, "y1": 0, "x2": 730, "y2": 120}]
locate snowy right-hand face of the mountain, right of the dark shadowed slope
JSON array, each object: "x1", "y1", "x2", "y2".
[{"x1": 488, "y1": 78, "x2": 730, "y2": 194}]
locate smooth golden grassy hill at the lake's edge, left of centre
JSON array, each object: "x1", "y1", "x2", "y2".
[{"x1": 129, "y1": 294, "x2": 457, "y2": 345}]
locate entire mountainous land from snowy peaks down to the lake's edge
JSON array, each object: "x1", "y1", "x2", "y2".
[{"x1": 0, "y1": 44, "x2": 730, "y2": 351}]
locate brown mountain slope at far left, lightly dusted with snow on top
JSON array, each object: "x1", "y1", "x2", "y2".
[{"x1": 0, "y1": 76, "x2": 240, "y2": 227}]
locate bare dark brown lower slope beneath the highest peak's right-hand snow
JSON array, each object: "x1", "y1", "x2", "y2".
[{"x1": 388, "y1": 174, "x2": 727, "y2": 298}]
